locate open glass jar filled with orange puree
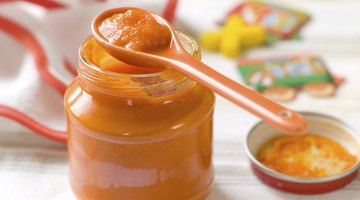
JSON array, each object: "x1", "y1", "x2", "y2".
[{"x1": 65, "y1": 33, "x2": 214, "y2": 200}]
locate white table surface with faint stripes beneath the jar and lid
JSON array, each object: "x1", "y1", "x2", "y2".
[{"x1": 0, "y1": 0, "x2": 360, "y2": 200}]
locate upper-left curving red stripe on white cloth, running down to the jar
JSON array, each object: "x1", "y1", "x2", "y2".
[{"x1": 0, "y1": 16, "x2": 66, "y2": 95}]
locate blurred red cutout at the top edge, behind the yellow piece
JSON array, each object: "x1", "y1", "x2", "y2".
[{"x1": 227, "y1": 1, "x2": 310, "y2": 39}]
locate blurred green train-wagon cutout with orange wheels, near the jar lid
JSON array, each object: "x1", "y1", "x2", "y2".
[{"x1": 238, "y1": 55, "x2": 340, "y2": 101}]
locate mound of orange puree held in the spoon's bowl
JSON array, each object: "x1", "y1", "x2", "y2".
[{"x1": 99, "y1": 10, "x2": 171, "y2": 51}]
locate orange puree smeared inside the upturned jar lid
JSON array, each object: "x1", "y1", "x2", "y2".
[{"x1": 257, "y1": 134, "x2": 357, "y2": 178}]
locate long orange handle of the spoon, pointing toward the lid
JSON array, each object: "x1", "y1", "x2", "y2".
[{"x1": 167, "y1": 54, "x2": 307, "y2": 134}]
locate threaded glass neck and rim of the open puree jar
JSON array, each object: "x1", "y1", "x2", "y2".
[{"x1": 78, "y1": 32, "x2": 201, "y2": 99}]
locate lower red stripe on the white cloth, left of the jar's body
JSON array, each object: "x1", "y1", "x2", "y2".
[{"x1": 0, "y1": 105, "x2": 67, "y2": 143}]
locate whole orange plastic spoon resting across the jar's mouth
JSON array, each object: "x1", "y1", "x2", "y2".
[{"x1": 92, "y1": 7, "x2": 307, "y2": 134}]
